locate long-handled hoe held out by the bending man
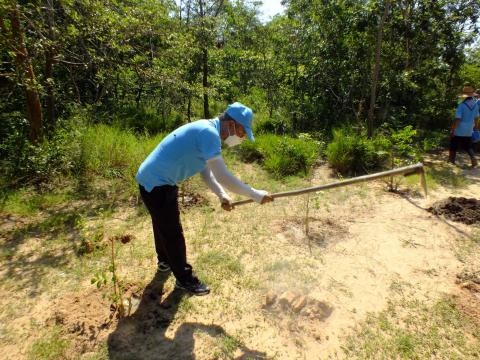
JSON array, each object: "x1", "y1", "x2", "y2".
[{"x1": 232, "y1": 163, "x2": 427, "y2": 206}]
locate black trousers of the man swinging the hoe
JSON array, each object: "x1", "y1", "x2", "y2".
[{"x1": 140, "y1": 185, "x2": 193, "y2": 282}]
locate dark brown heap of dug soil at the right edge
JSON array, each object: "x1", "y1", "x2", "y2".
[{"x1": 428, "y1": 197, "x2": 480, "y2": 225}]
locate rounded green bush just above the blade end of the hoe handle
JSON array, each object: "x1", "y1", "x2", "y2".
[{"x1": 325, "y1": 128, "x2": 385, "y2": 175}]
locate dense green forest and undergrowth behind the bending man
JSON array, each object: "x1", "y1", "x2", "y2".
[{"x1": 0, "y1": 0, "x2": 480, "y2": 187}]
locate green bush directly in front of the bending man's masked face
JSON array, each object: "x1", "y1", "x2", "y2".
[{"x1": 238, "y1": 134, "x2": 320, "y2": 177}]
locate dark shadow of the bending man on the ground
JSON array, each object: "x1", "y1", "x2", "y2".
[{"x1": 107, "y1": 272, "x2": 267, "y2": 360}]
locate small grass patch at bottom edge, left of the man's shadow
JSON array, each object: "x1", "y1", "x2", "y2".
[{"x1": 28, "y1": 326, "x2": 70, "y2": 360}]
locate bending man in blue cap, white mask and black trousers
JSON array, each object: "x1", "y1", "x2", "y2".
[{"x1": 136, "y1": 102, "x2": 273, "y2": 295}]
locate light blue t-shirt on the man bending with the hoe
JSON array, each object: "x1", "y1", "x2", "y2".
[{"x1": 135, "y1": 118, "x2": 221, "y2": 192}]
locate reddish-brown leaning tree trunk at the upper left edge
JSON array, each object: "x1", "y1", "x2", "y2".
[{"x1": 10, "y1": 9, "x2": 42, "y2": 143}]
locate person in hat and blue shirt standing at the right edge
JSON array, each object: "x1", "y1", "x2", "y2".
[{"x1": 449, "y1": 85, "x2": 480, "y2": 167}]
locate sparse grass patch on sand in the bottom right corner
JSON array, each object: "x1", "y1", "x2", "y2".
[{"x1": 343, "y1": 299, "x2": 480, "y2": 360}]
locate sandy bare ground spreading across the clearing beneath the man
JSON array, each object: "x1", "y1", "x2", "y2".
[{"x1": 0, "y1": 153, "x2": 480, "y2": 359}]
